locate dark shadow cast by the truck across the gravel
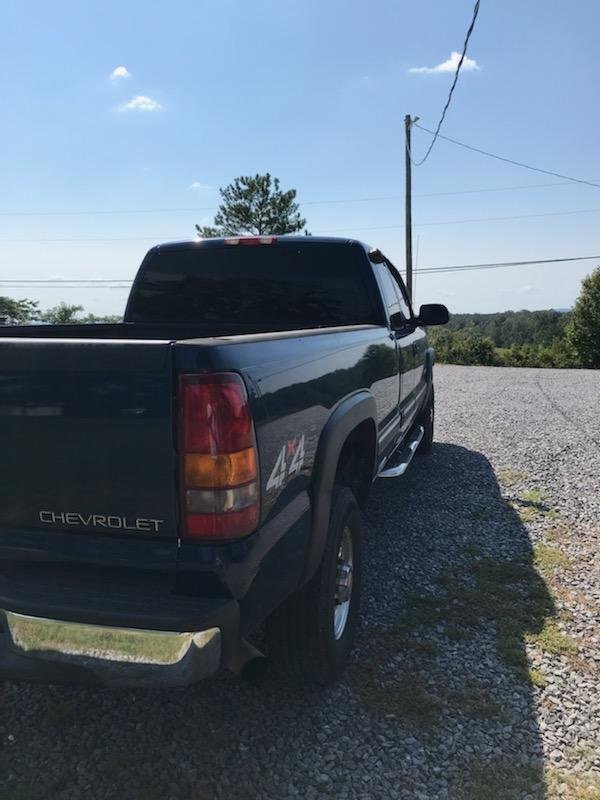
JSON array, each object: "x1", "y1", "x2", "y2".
[{"x1": 0, "y1": 444, "x2": 555, "y2": 800}]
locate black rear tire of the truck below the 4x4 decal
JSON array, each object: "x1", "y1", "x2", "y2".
[{"x1": 266, "y1": 486, "x2": 362, "y2": 684}]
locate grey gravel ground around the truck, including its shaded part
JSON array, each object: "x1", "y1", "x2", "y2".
[{"x1": 0, "y1": 366, "x2": 600, "y2": 800}]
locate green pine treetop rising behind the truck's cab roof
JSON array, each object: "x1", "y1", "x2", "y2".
[{"x1": 196, "y1": 172, "x2": 306, "y2": 238}]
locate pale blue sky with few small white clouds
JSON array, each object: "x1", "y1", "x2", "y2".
[{"x1": 0, "y1": 0, "x2": 600, "y2": 314}]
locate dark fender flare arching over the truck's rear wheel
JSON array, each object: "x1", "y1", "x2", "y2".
[{"x1": 300, "y1": 391, "x2": 377, "y2": 585}]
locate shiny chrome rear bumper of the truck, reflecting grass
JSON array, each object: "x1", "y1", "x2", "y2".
[{"x1": 0, "y1": 611, "x2": 221, "y2": 686}]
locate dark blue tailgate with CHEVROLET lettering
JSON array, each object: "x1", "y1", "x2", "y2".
[{"x1": 0, "y1": 338, "x2": 177, "y2": 544}]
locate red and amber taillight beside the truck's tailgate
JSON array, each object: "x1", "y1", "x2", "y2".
[{"x1": 179, "y1": 372, "x2": 260, "y2": 540}]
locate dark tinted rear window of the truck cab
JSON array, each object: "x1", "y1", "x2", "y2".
[{"x1": 127, "y1": 242, "x2": 377, "y2": 330}]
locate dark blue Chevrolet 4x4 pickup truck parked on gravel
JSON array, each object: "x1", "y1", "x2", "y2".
[{"x1": 0, "y1": 236, "x2": 448, "y2": 686}]
